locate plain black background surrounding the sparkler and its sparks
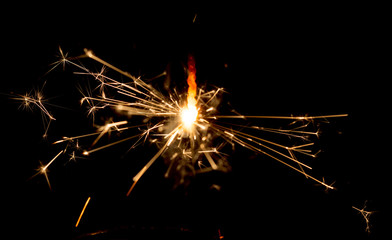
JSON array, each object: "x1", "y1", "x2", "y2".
[{"x1": 1, "y1": 3, "x2": 390, "y2": 239}]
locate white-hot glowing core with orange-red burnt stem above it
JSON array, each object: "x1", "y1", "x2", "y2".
[{"x1": 181, "y1": 55, "x2": 199, "y2": 130}]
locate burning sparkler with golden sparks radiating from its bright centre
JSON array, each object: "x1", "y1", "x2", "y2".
[{"x1": 23, "y1": 47, "x2": 347, "y2": 196}]
